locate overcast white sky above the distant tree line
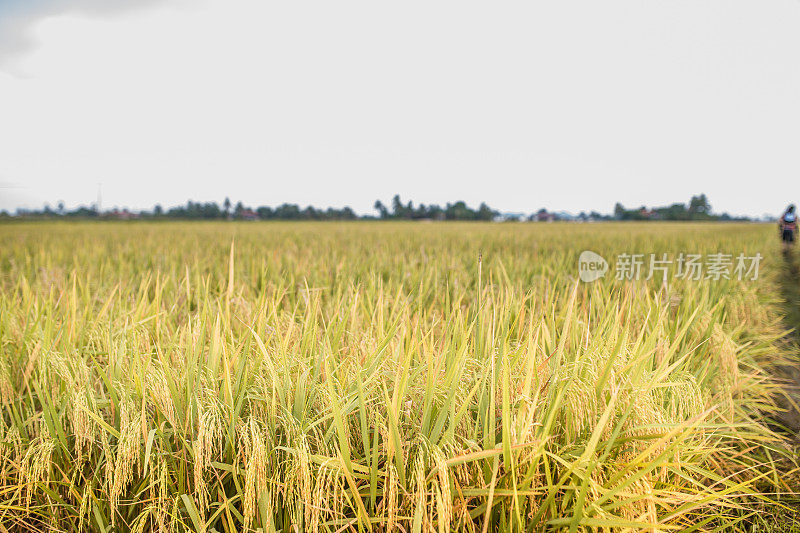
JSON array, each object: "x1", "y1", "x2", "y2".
[{"x1": 0, "y1": 0, "x2": 800, "y2": 215}]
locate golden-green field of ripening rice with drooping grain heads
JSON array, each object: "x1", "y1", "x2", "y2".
[{"x1": 0, "y1": 222, "x2": 800, "y2": 533}]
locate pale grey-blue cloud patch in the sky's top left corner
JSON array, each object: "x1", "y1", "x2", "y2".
[{"x1": 0, "y1": 0, "x2": 170, "y2": 68}]
